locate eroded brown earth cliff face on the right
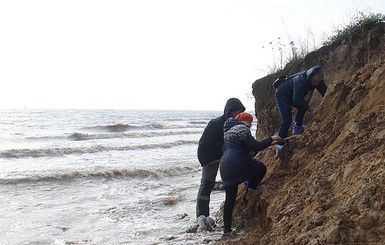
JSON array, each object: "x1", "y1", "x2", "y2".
[{"x1": 220, "y1": 23, "x2": 385, "y2": 244}]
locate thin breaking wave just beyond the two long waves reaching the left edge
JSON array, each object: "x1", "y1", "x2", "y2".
[{"x1": 68, "y1": 130, "x2": 201, "y2": 141}]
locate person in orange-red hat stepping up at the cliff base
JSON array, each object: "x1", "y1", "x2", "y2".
[{"x1": 220, "y1": 112, "x2": 282, "y2": 234}]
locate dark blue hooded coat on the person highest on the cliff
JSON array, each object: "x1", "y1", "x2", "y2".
[{"x1": 276, "y1": 66, "x2": 327, "y2": 111}]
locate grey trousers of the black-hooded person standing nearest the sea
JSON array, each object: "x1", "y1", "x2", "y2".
[{"x1": 196, "y1": 160, "x2": 219, "y2": 218}]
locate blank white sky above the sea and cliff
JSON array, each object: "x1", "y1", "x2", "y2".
[{"x1": 0, "y1": 0, "x2": 385, "y2": 110}]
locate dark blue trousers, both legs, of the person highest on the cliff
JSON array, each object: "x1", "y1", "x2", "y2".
[{"x1": 275, "y1": 94, "x2": 305, "y2": 139}]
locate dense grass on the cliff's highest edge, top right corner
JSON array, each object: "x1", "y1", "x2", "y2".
[{"x1": 323, "y1": 12, "x2": 385, "y2": 46}]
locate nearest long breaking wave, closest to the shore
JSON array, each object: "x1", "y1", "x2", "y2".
[{"x1": 0, "y1": 165, "x2": 197, "y2": 185}]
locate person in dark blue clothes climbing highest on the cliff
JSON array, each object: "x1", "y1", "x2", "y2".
[{"x1": 275, "y1": 65, "x2": 327, "y2": 156}]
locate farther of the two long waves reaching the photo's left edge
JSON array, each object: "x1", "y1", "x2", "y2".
[{"x1": 0, "y1": 140, "x2": 198, "y2": 158}]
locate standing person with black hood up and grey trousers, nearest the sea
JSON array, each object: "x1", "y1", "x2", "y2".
[{"x1": 196, "y1": 98, "x2": 246, "y2": 228}]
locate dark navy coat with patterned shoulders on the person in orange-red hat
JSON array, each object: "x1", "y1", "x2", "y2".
[{"x1": 220, "y1": 118, "x2": 273, "y2": 188}]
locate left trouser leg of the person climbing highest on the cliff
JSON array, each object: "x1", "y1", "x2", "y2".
[{"x1": 275, "y1": 94, "x2": 292, "y2": 139}]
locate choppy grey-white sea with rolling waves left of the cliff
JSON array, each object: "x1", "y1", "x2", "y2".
[{"x1": 0, "y1": 109, "x2": 230, "y2": 244}]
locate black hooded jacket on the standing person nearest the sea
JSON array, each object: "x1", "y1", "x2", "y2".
[{"x1": 198, "y1": 98, "x2": 246, "y2": 166}]
